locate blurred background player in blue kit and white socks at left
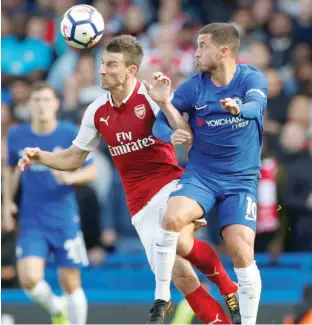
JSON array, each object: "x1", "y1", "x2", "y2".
[{"x1": 3, "y1": 83, "x2": 96, "y2": 324}]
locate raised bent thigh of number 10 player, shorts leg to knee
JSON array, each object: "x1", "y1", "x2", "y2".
[{"x1": 163, "y1": 179, "x2": 215, "y2": 231}]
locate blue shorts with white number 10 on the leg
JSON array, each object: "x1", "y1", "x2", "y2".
[{"x1": 170, "y1": 165, "x2": 258, "y2": 231}]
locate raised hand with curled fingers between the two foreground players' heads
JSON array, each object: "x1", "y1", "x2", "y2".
[{"x1": 143, "y1": 72, "x2": 171, "y2": 105}]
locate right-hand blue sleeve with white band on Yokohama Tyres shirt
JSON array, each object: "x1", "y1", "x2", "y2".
[{"x1": 244, "y1": 71, "x2": 268, "y2": 113}]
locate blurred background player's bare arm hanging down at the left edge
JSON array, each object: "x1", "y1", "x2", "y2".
[{"x1": 2, "y1": 166, "x2": 20, "y2": 231}]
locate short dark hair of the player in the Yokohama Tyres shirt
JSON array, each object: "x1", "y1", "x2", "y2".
[{"x1": 199, "y1": 23, "x2": 240, "y2": 54}]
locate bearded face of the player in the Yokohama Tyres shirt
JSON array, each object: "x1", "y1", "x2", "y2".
[{"x1": 195, "y1": 34, "x2": 222, "y2": 73}]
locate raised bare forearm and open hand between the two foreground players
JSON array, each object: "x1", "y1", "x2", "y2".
[{"x1": 143, "y1": 72, "x2": 192, "y2": 134}]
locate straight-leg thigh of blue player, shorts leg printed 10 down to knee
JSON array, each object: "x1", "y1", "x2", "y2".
[{"x1": 218, "y1": 192, "x2": 257, "y2": 267}]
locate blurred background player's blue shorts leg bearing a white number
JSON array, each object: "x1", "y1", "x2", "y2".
[{"x1": 51, "y1": 228, "x2": 89, "y2": 269}]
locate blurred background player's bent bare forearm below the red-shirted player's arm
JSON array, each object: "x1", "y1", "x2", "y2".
[{"x1": 53, "y1": 164, "x2": 97, "y2": 185}]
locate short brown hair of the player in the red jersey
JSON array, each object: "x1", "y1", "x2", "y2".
[{"x1": 106, "y1": 35, "x2": 144, "y2": 69}]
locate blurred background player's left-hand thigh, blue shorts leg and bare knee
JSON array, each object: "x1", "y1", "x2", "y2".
[{"x1": 16, "y1": 229, "x2": 49, "y2": 289}]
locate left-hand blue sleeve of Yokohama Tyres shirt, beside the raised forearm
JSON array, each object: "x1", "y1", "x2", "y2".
[{"x1": 171, "y1": 77, "x2": 198, "y2": 113}]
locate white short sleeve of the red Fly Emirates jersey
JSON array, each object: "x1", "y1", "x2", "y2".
[{"x1": 73, "y1": 103, "x2": 100, "y2": 151}]
